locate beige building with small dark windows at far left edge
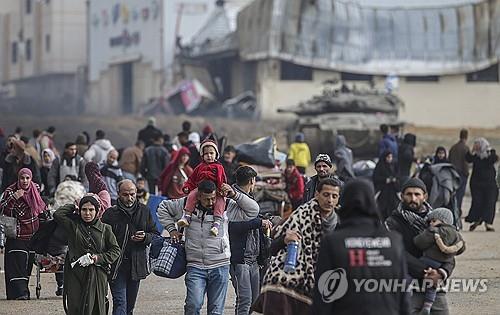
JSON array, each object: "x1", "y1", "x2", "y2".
[{"x1": 0, "y1": 0, "x2": 87, "y2": 114}]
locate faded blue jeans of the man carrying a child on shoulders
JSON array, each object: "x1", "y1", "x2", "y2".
[{"x1": 184, "y1": 265, "x2": 229, "y2": 315}]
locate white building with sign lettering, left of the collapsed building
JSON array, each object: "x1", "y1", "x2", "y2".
[{"x1": 87, "y1": 0, "x2": 249, "y2": 114}]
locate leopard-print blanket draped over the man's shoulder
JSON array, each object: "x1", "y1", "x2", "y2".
[{"x1": 261, "y1": 199, "x2": 328, "y2": 304}]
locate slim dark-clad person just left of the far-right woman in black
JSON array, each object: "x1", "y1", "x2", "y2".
[{"x1": 449, "y1": 129, "x2": 470, "y2": 223}]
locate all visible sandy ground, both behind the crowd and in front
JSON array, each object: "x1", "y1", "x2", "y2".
[{"x1": 0, "y1": 115, "x2": 500, "y2": 315}]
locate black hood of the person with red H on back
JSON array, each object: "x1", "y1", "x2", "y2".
[{"x1": 338, "y1": 179, "x2": 380, "y2": 221}]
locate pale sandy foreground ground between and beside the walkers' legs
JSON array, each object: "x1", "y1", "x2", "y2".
[{"x1": 0, "y1": 199, "x2": 500, "y2": 315}]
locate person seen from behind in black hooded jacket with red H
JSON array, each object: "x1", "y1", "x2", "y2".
[{"x1": 312, "y1": 179, "x2": 410, "y2": 315}]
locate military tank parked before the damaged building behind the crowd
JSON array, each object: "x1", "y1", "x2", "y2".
[{"x1": 278, "y1": 85, "x2": 404, "y2": 159}]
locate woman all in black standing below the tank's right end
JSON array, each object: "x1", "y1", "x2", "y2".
[{"x1": 373, "y1": 151, "x2": 399, "y2": 220}]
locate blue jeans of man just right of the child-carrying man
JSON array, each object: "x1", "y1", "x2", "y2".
[{"x1": 229, "y1": 262, "x2": 260, "y2": 315}]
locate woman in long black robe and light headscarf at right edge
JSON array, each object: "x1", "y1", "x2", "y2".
[{"x1": 465, "y1": 138, "x2": 498, "y2": 232}]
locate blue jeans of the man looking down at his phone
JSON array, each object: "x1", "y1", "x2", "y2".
[{"x1": 109, "y1": 261, "x2": 140, "y2": 315}]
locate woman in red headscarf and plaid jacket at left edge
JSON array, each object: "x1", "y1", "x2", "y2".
[{"x1": 0, "y1": 168, "x2": 47, "y2": 300}]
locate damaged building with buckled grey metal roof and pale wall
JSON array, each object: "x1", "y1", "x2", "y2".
[{"x1": 179, "y1": 0, "x2": 500, "y2": 127}]
